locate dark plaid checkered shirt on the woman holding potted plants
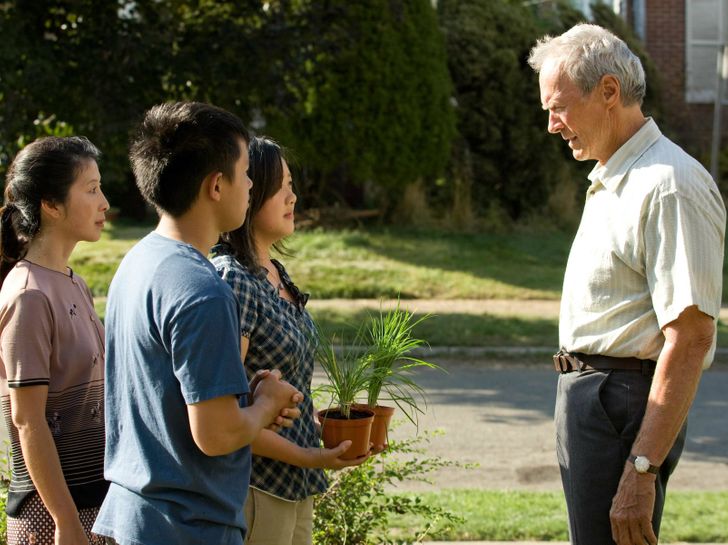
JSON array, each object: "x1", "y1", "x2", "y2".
[{"x1": 212, "y1": 244, "x2": 328, "y2": 501}]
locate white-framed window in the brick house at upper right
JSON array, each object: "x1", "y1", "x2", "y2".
[{"x1": 684, "y1": 0, "x2": 728, "y2": 103}]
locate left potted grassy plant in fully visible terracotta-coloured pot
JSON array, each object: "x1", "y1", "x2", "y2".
[{"x1": 316, "y1": 327, "x2": 382, "y2": 460}]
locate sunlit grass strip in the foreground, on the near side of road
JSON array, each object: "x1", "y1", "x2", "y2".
[{"x1": 392, "y1": 489, "x2": 728, "y2": 543}]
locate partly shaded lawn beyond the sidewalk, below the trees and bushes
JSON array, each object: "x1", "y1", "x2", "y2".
[{"x1": 71, "y1": 224, "x2": 571, "y2": 299}]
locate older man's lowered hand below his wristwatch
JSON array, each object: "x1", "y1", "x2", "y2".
[{"x1": 609, "y1": 462, "x2": 657, "y2": 545}]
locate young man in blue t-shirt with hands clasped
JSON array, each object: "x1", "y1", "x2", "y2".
[{"x1": 94, "y1": 103, "x2": 300, "y2": 545}]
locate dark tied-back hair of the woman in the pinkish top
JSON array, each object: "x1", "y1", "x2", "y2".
[{"x1": 0, "y1": 136, "x2": 101, "y2": 286}]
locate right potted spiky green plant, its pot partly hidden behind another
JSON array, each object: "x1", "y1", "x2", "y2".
[{"x1": 362, "y1": 300, "x2": 441, "y2": 453}]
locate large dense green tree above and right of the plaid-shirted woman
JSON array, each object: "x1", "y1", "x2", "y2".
[{"x1": 269, "y1": 0, "x2": 454, "y2": 210}]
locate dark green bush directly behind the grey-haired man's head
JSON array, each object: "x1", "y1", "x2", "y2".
[{"x1": 438, "y1": 0, "x2": 661, "y2": 227}]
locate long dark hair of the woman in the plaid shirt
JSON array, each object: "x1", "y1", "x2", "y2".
[{"x1": 221, "y1": 136, "x2": 289, "y2": 270}]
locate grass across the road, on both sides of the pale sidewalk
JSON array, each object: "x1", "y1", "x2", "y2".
[{"x1": 71, "y1": 224, "x2": 728, "y2": 346}]
